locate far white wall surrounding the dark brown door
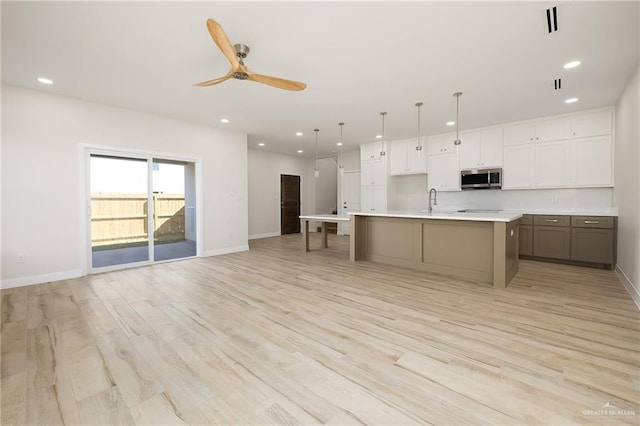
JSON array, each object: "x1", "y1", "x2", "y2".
[{"x1": 248, "y1": 149, "x2": 315, "y2": 239}]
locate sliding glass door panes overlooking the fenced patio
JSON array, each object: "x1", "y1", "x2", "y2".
[{"x1": 89, "y1": 153, "x2": 197, "y2": 269}]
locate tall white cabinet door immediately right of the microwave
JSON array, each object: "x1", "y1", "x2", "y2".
[{"x1": 502, "y1": 144, "x2": 535, "y2": 189}]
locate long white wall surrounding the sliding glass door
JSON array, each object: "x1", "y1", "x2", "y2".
[{"x1": 1, "y1": 85, "x2": 248, "y2": 288}]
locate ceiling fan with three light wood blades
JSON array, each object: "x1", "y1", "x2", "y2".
[{"x1": 195, "y1": 19, "x2": 307, "y2": 90}]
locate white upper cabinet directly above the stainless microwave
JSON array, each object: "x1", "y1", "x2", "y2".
[{"x1": 460, "y1": 127, "x2": 503, "y2": 170}]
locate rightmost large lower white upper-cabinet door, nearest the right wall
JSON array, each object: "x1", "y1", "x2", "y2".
[{"x1": 573, "y1": 136, "x2": 613, "y2": 186}]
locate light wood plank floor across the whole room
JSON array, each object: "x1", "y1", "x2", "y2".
[{"x1": 1, "y1": 234, "x2": 640, "y2": 425}]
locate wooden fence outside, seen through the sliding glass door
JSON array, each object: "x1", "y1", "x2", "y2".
[{"x1": 91, "y1": 194, "x2": 185, "y2": 247}]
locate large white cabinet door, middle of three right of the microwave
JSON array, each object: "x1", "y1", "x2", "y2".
[{"x1": 536, "y1": 140, "x2": 573, "y2": 188}]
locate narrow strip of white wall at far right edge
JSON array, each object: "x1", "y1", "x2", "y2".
[{"x1": 614, "y1": 64, "x2": 640, "y2": 306}]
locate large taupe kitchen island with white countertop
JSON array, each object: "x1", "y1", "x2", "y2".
[{"x1": 349, "y1": 211, "x2": 522, "y2": 288}]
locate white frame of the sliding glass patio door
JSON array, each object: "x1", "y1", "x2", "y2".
[{"x1": 78, "y1": 144, "x2": 203, "y2": 276}]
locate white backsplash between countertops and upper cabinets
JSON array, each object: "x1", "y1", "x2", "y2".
[{"x1": 388, "y1": 175, "x2": 613, "y2": 213}]
